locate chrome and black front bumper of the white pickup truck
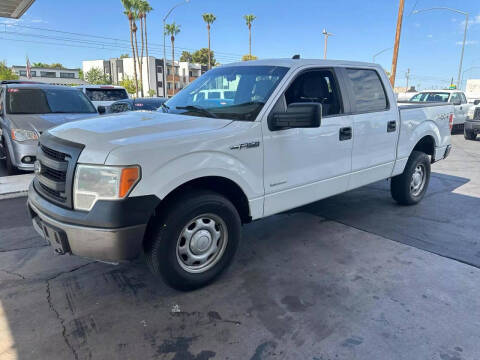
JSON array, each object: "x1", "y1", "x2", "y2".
[{"x1": 28, "y1": 185, "x2": 156, "y2": 262}]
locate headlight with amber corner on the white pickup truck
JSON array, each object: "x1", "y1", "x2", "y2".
[{"x1": 73, "y1": 164, "x2": 140, "y2": 211}]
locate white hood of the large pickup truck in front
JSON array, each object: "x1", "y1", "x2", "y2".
[{"x1": 49, "y1": 111, "x2": 232, "y2": 163}]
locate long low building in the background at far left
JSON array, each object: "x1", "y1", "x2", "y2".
[{"x1": 12, "y1": 65, "x2": 86, "y2": 85}]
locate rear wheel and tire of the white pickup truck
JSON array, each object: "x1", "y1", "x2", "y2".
[{"x1": 390, "y1": 151, "x2": 430, "y2": 205}]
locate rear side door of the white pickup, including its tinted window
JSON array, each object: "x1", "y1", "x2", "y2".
[{"x1": 343, "y1": 68, "x2": 399, "y2": 189}]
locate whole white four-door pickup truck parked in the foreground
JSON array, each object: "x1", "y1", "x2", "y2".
[{"x1": 28, "y1": 59, "x2": 453, "y2": 289}]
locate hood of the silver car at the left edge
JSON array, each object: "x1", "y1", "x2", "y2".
[{"x1": 7, "y1": 113, "x2": 98, "y2": 134}]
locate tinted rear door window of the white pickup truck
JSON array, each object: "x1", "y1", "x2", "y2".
[{"x1": 346, "y1": 69, "x2": 388, "y2": 113}]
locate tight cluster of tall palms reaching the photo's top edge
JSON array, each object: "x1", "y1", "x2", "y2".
[{"x1": 121, "y1": 0, "x2": 153, "y2": 97}]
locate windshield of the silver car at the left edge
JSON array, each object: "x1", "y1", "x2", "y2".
[{"x1": 6, "y1": 88, "x2": 97, "y2": 114}]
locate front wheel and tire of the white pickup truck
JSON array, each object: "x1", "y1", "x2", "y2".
[{"x1": 145, "y1": 191, "x2": 241, "y2": 290}]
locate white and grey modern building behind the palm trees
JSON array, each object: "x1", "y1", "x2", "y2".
[{"x1": 82, "y1": 56, "x2": 208, "y2": 97}]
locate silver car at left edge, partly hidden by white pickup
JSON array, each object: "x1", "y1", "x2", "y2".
[{"x1": 0, "y1": 83, "x2": 102, "y2": 174}]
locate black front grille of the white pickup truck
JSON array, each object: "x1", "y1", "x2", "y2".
[{"x1": 33, "y1": 133, "x2": 83, "y2": 209}]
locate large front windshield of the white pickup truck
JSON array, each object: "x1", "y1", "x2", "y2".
[{"x1": 163, "y1": 66, "x2": 289, "y2": 121}]
